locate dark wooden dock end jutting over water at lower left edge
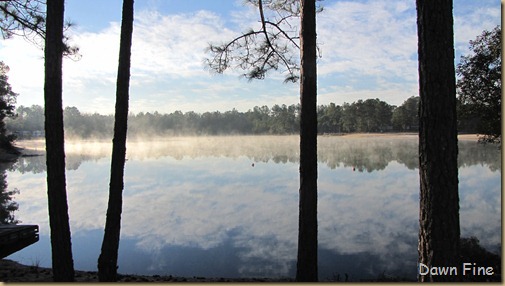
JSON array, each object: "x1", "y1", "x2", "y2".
[{"x1": 0, "y1": 224, "x2": 39, "y2": 258}]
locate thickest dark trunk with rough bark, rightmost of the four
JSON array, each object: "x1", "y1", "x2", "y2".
[{"x1": 417, "y1": 0, "x2": 461, "y2": 281}]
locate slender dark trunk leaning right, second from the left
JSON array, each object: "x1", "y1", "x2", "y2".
[{"x1": 98, "y1": 0, "x2": 133, "y2": 282}]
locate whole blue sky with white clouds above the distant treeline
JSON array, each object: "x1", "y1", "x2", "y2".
[{"x1": 0, "y1": 0, "x2": 501, "y2": 114}]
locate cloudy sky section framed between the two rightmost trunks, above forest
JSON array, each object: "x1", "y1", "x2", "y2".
[{"x1": 317, "y1": 1, "x2": 418, "y2": 105}]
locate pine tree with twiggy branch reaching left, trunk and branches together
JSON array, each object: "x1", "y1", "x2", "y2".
[{"x1": 207, "y1": 0, "x2": 318, "y2": 281}]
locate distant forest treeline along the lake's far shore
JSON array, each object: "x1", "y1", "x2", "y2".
[{"x1": 6, "y1": 96, "x2": 474, "y2": 138}]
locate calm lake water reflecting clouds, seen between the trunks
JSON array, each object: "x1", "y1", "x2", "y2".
[{"x1": 3, "y1": 136, "x2": 501, "y2": 281}]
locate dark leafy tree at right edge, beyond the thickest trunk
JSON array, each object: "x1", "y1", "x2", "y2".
[{"x1": 456, "y1": 26, "x2": 502, "y2": 143}]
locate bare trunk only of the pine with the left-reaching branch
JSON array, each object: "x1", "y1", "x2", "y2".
[{"x1": 296, "y1": 0, "x2": 318, "y2": 281}]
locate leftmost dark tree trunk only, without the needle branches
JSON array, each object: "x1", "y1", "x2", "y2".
[{"x1": 44, "y1": 0, "x2": 74, "y2": 281}]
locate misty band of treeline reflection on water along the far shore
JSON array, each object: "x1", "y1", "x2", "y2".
[{"x1": 13, "y1": 136, "x2": 501, "y2": 173}]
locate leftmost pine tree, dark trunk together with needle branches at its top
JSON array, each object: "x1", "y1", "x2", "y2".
[{"x1": 0, "y1": 3, "x2": 78, "y2": 281}]
